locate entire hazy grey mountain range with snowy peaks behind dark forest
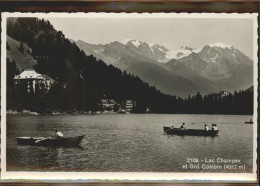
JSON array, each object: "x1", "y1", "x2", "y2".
[{"x1": 74, "y1": 39, "x2": 253, "y2": 97}]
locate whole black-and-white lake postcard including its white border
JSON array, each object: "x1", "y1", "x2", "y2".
[{"x1": 1, "y1": 13, "x2": 258, "y2": 181}]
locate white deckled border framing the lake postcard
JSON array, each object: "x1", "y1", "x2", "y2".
[{"x1": 1, "y1": 12, "x2": 258, "y2": 183}]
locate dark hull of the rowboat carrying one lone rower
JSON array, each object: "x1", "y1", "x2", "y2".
[{"x1": 16, "y1": 135, "x2": 85, "y2": 147}]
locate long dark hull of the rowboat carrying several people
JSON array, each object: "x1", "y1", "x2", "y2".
[{"x1": 163, "y1": 126, "x2": 219, "y2": 136}]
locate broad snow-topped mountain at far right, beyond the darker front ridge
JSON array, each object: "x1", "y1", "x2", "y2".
[{"x1": 165, "y1": 43, "x2": 253, "y2": 91}]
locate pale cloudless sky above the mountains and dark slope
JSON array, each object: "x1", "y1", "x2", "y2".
[{"x1": 47, "y1": 17, "x2": 254, "y2": 59}]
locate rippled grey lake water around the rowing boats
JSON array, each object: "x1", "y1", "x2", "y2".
[{"x1": 7, "y1": 114, "x2": 253, "y2": 172}]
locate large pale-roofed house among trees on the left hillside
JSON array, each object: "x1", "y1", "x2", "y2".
[{"x1": 14, "y1": 69, "x2": 54, "y2": 94}]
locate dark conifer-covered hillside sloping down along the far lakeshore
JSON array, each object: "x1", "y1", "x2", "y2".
[{"x1": 7, "y1": 18, "x2": 253, "y2": 114}]
